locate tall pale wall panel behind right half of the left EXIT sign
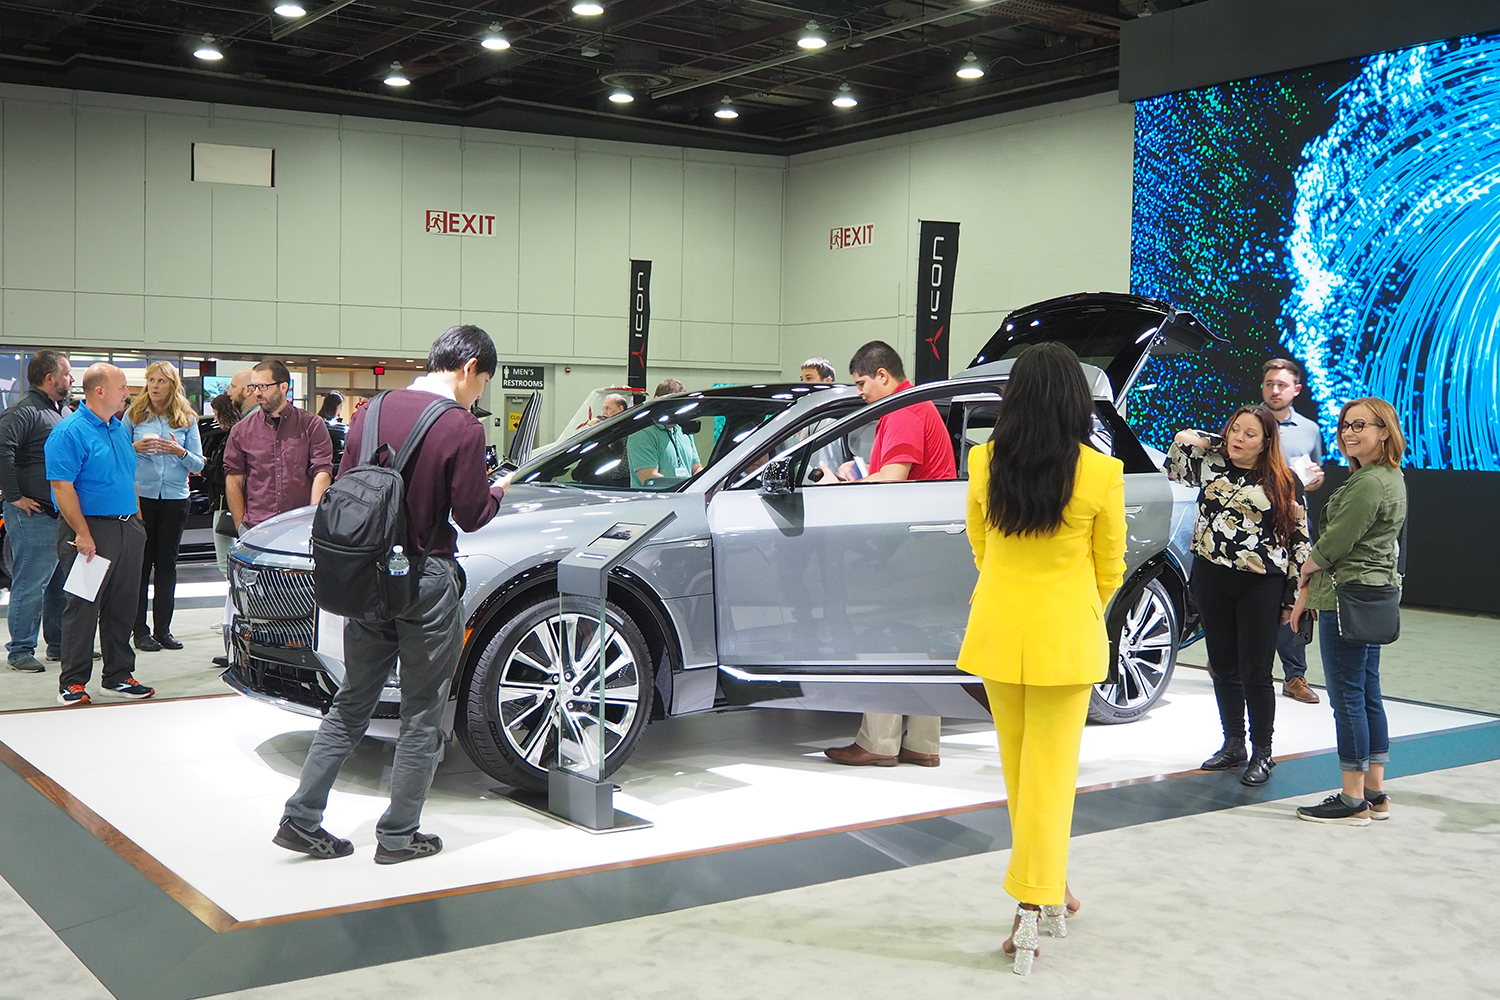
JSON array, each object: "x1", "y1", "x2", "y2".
[{"x1": 459, "y1": 139, "x2": 521, "y2": 310}]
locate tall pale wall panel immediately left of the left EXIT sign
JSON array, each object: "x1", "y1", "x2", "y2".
[{"x1": 339, "y1": 129, "x2": 402, "y2": 307}]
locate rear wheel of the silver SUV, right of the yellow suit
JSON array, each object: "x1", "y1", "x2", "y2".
[{"x1": 1089, "y1": 577, "x2": 1181, "y2": 726}]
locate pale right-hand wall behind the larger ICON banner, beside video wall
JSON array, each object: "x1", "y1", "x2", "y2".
[{"x1": 782, "y1": 94, "x2": 1133, "y2": 378}]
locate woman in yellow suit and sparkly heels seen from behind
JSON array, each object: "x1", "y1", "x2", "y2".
[{"x1": 959, "y1": 343, "x2": 1125, "y2": 976}]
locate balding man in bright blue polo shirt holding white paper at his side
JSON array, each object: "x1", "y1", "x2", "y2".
[{"x1": 47, "y1": 363, "x2": 156, "y2": 705}]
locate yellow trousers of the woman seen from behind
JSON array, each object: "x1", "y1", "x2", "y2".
[{"x1": 984, "y1": 679, "x2": 1094, "y2": 906}]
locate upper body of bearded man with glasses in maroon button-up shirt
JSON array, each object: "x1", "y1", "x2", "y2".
[{"x1": 224, "y1": 360, "x2": 333, "y2": 532}]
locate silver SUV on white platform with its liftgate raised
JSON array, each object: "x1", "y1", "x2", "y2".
[{"x1": 224, "y1": 294, "x2": 1214, "y2": 790}]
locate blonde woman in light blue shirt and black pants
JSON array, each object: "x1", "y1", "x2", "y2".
[{"x1": 125, "y1": 361, "x2": 204, "y2": 652}]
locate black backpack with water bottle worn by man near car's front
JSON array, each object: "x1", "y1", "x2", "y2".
[{"x1": 312, "y1": 393, "x2": 462, "y2": 622}]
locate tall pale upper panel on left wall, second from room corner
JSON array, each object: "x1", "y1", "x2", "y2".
[{"x1": 683, "y1": 160, "x2": 735, "y2": 322}]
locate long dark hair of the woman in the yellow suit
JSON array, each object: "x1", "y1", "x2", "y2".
[{"x1": 986, "y1": 343, "x2": 1094, "y2": 535}]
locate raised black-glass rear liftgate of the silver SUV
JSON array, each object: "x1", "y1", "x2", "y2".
[{"x1": 969, "y1": 292, "x2": 1224, "y2": 408}]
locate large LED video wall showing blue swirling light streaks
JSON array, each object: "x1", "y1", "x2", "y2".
[{"x1": 1130, "y1": 36, "x2": 1500, "y2": 471}]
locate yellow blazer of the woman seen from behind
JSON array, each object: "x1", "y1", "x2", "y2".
[{"x1": 959, "y1": 444, "x2": 1125, "y2": 685}]
